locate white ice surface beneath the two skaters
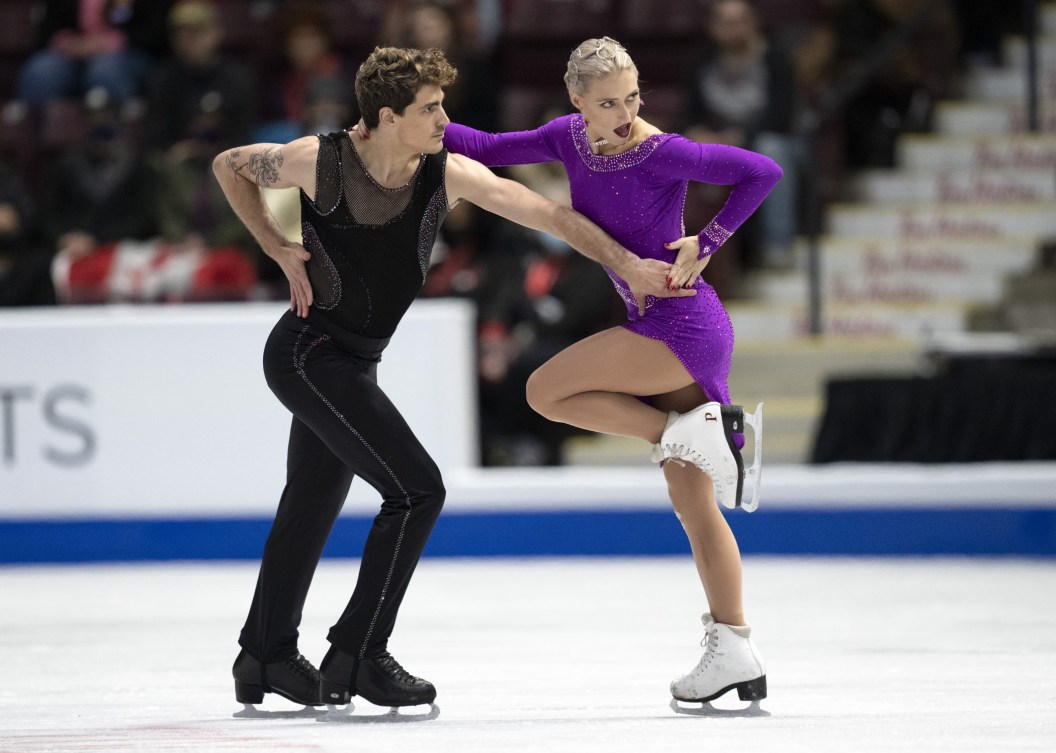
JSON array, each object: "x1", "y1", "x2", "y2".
[{"x1": 0, "y1": 558, "x2": 1056, "y2": 753}]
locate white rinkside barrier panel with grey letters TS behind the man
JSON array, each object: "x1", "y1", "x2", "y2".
[{"x1": 0, "y1": 300, "x2": 477, "y2": 519}]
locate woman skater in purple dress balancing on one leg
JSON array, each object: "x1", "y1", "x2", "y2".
[{"x1": 445, "y1": 37, "x2": 781, "y2": 702}]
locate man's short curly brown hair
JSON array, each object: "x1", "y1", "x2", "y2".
[{"x1": 356, "y1": 48, "x2": 458, "y2": 129}]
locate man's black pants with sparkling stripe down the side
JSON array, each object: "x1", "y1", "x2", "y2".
[{"x1": 239, "y1": 313, "x2": 445, "y2": 662}]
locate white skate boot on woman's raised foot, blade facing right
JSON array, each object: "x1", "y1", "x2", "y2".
[{"x1": 650, "y1": 402, "x2": 762, "y2": 512}]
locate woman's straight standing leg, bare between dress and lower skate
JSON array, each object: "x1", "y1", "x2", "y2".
[{"x1": 653, "y1": 383, "x2": 747, "y2": 625}]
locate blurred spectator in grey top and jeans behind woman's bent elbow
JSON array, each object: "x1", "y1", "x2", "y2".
[{"x1": 684, "y1": 0, "x2": 799, "y2": 268}]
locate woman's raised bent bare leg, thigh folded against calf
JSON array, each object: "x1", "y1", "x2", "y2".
[{"x1": 527, "y1": 327, "x2": 694, "y2": 443}]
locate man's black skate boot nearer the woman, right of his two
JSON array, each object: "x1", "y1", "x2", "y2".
[{"x1": 319, "y1": 646, "x2": 436, "y2": 707}]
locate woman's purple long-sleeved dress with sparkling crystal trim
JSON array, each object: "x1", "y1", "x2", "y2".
[{"x1": 444, "y1": 113, "x2": 781, "y2": 402}]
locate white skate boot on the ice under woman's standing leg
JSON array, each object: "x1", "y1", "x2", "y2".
[{"x1": 671, "y1": 613, "x2": 770, "y2": 716}]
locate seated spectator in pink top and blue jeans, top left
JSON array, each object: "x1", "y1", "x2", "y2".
[{"x1": 18, "y1": 0, "x2": 171, "y2": 102}]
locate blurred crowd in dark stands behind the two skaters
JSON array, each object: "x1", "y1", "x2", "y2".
[{"x1": 0, "y1": 0, "x2": 1043, "y2": 465}]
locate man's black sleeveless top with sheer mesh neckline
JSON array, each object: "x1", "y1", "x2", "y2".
[{"x1": 301, "y1": 131, "x2": 448, "y2": 339}]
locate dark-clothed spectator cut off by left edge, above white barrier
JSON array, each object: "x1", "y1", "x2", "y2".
[{"x1": 0, "y1": 156, "x2": 55, "y2": 306}]
